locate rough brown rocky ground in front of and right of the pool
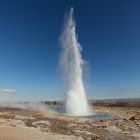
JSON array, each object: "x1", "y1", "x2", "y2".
[{"x1": 0, "y1": 107, "x2": 140, "y2": 140}]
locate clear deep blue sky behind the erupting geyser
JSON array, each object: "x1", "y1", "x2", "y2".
[{"x1": 0, "y1": 0, "x2": 140, "y2": 100}]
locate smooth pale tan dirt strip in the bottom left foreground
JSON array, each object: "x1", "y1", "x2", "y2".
[{"x1": 0, "y1": 127, "x2": 82, "y2": 140}]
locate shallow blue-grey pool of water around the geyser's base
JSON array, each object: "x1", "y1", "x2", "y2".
[{"x1": 50, "y1": 105, "x2": 118, "y2": 120}]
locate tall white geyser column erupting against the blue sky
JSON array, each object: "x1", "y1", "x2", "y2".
[{"x1": 60, "y1": 8, "x2": 89, "y2": 116}]
